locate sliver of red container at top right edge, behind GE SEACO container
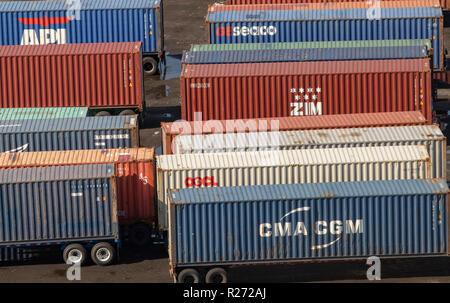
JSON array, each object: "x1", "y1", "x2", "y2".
[{"x1": 227, "y1": 0, "x2": 450, "y2": 10}]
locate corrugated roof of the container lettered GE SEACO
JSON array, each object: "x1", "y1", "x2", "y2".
[{"x1": 206, "y1": 5, "x2": 442, "y2": 25}]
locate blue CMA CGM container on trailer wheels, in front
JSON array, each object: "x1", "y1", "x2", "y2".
[{"x1": 169, "y1": 179, "x2": 449, "y2": 282}]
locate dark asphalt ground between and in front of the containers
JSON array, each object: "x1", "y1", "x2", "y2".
[{"x1": 0, "y1": 0, "x2": 450, "y2": 283}]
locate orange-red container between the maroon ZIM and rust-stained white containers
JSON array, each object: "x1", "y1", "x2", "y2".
[{"x1": 161, "y1": 112, "x2": 426, "y2": 155}]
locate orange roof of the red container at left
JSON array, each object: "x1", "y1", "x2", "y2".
[{"x1": 0, "y1": 148, "x2": 155, "y2": 169}]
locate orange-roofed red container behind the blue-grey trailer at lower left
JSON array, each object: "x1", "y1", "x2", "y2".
[{"x1": 0, "y1": 148, "x2": 156, "y2": 224}]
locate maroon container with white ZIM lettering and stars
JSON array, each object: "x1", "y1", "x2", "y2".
[{"x1": 180, "y1": 59, "x2": 432, "y2": 122}]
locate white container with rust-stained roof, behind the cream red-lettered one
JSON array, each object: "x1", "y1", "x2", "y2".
[{"x1": 173, "y1": 125, "x2": 447, "y2": 178}]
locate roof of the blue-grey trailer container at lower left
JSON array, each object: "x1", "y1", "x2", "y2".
[{"x1": 0, "y1": 164, "x2": 114, "y2": 184}]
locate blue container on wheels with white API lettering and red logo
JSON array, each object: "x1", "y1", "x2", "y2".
[{"x1": 0, "y1": 0, "x2": 164, "y2": 74}]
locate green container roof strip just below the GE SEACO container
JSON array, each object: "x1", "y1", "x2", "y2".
[{"x1": 191, "y1": 39, "x2": 431, "y2": 52}]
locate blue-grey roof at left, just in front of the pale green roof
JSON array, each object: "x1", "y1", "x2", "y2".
[{"x1": 0, "y1": 116, "x2": 137, "y2": 133}]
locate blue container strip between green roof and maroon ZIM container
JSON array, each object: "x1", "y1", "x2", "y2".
[{"x1": 182, "y1": 46, "x2": 428, "y2": 64}]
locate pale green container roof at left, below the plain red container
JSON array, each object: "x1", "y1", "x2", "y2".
[{"x1": 0, "y1": 107, "x2": 88, "y2": 120}]
